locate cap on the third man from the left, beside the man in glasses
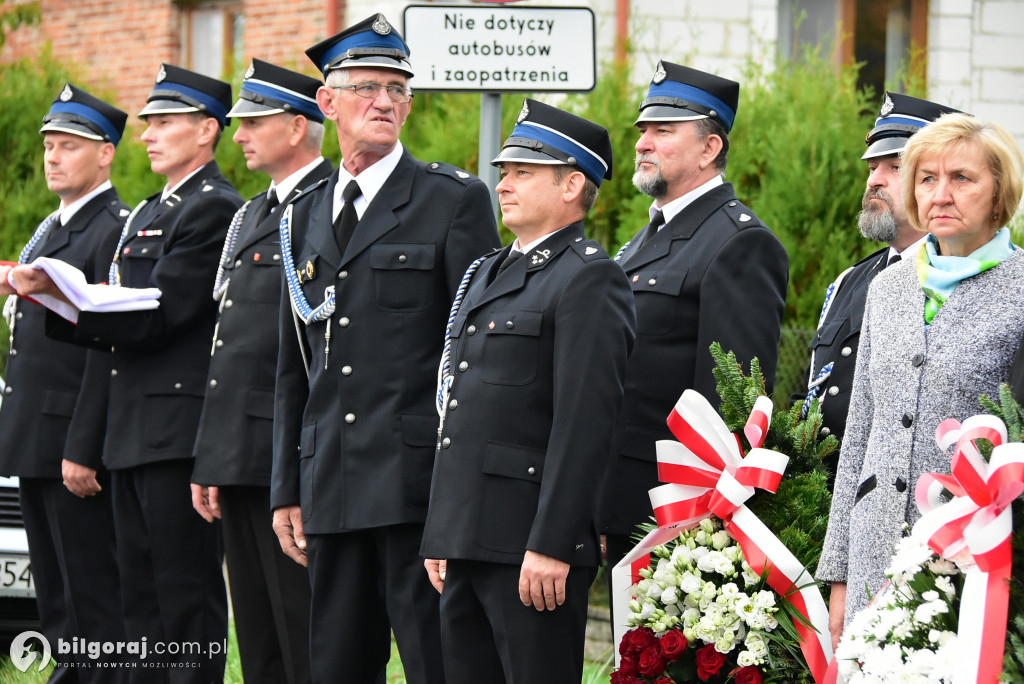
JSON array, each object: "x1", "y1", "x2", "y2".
[{"x1": 227, "y1": 59, "x2": 324, "y2": 124}]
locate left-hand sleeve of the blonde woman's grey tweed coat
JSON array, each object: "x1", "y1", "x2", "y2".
[{"x1": 815, "y1": 297, "x2": 873, "y2": 582}]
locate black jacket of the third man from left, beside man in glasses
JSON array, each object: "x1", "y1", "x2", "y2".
[{"x1": 193, "y1": 160, "x2": 334, "y2": 486}]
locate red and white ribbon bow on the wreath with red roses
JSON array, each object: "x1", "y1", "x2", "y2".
[{"x1": 611, "y1": 389, "x2": 831, "y2": 682}]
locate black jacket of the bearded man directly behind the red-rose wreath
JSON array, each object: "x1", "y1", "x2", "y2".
[{"x1": 599, "y1": 183, "x2": 790, "y2": 535}]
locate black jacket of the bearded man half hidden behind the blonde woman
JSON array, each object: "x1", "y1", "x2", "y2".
[{"x1": 792, "y1": 247, "x2": 889, "y2": 450}]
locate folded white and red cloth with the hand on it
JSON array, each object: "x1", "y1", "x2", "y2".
[{"x1": 9, "y1": 257, "x2": 162, "y2": 323}]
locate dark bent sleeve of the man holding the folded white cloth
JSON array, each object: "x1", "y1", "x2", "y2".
[{"x1": 75, "y1": 194, "x2": 240, "y2": 348}]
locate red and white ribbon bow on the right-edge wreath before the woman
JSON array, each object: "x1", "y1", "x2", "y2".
[{"x1": 912, "y1": 416, "x2": 1024, "y2": 684}]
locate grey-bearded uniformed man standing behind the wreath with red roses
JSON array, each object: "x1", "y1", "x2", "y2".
[{"x1": 598, "y1": 61, "x2": 788, "y2": 576}]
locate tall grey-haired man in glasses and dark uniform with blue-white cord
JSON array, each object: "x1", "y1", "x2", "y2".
[{"x1": 270, "y1": 14, "x2": 500, "y2": 684}]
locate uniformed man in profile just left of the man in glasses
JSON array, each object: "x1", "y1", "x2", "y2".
[{"x1": 191, "y1": 59, "x2": 334, "y2": 684}]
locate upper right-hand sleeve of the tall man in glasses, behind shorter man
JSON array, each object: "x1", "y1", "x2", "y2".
[{"x1": 444, "y1": 180, "x2": 502, "y2": 299}]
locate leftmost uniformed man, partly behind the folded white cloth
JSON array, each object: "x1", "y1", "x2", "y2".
[{"x1": 0, "y1": 84, "x2": 129, "y2": 682}]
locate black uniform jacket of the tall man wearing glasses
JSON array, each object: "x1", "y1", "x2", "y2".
[{"x1": 270, "y1": 151, "x2": 500, "y2": 533}]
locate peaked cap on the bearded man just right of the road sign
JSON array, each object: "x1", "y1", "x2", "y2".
[{"x1": 635, "y1": 60, "x2": 739, "y2": 132}]
